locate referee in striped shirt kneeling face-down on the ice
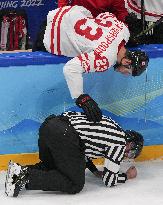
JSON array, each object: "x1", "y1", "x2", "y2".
[{"x1": 5, "y1": 112, "x2": 143, "y2": 197}]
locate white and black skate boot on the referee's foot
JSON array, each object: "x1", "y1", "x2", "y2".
[{"x1": 5, "y1": 161, "x2": 28, "y2": 197}]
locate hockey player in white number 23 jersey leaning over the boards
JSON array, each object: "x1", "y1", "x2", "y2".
[{"x1": 34, "y1": 6, "x2": 149, "y2": 122}]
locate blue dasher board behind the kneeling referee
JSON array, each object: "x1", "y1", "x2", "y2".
[{"x1": 0, "y1": 45, "x2": 163, "y2": 155}]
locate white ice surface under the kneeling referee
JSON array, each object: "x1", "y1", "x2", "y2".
[{"x1": 0, "y1": 161, "x2": 163, "y2": 205}]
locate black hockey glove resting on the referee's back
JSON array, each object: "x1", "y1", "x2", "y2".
[{"x1": 76, "y1": 94, "x2": 102, "y2": 122}]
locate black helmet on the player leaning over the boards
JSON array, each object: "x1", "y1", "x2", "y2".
[{"x1": 125, "y1": 50, "x2": 149, "y2": 76}]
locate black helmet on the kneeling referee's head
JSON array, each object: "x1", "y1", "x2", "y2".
[{"x1": 125, "y1": 130, "x2": 144, "y2": 158}]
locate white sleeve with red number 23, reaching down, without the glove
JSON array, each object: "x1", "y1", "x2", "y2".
[{"x1": 63, "y1": 51, "x2": 113, "y2": 98}]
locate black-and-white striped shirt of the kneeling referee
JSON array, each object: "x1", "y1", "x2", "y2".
[{"x1": 63, "y1": 112, "x2": 127, "y2": 186}]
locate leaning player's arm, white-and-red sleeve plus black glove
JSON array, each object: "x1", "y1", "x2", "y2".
[{"x1": 63, "y1": 51, "x2": 109, "y2": 122}]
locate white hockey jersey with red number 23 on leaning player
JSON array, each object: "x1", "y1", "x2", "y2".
[{"x1": 43, "y1": 6, "x2": 129, "y2": 98}]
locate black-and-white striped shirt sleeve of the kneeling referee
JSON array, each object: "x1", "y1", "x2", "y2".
[{"x1": 103, "y1": 145, "x2": 127, "y2": 187}]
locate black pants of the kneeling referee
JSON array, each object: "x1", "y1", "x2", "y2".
[{"x1": 28, "y1": 117, "x2": 85, "y2": 194}]
